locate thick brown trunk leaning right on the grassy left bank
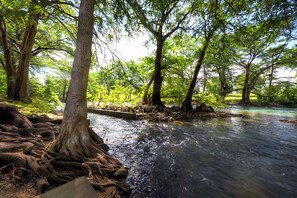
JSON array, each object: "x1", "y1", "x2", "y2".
[{"x1": 12, "y1": 9, "x2": 41, "y2": 100}]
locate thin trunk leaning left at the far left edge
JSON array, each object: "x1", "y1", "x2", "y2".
[{"x1": 0, "y1": 16, "x2": 15, "y2": 97}]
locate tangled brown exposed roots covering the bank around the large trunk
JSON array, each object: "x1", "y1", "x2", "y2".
[{"x1": 0, "y1": 106, "x2": 130, "y2": 197}]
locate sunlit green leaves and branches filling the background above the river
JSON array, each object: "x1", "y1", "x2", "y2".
[{"x1": 0, "y1": 0, "x2": 297, "y2": 112}]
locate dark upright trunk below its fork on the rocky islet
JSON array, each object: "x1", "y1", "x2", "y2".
[{"x1": 152, "y1": 37, "x2": 165, "y2": 107}]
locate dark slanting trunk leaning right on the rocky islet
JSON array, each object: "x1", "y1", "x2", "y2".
[{"x1": 182, "y1": 40, "x2": 209, "y2": 111}]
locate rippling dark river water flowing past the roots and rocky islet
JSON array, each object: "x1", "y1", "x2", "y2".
[{"x1": 89, "y1": 107, "x2": 297, "y2": 198}]
